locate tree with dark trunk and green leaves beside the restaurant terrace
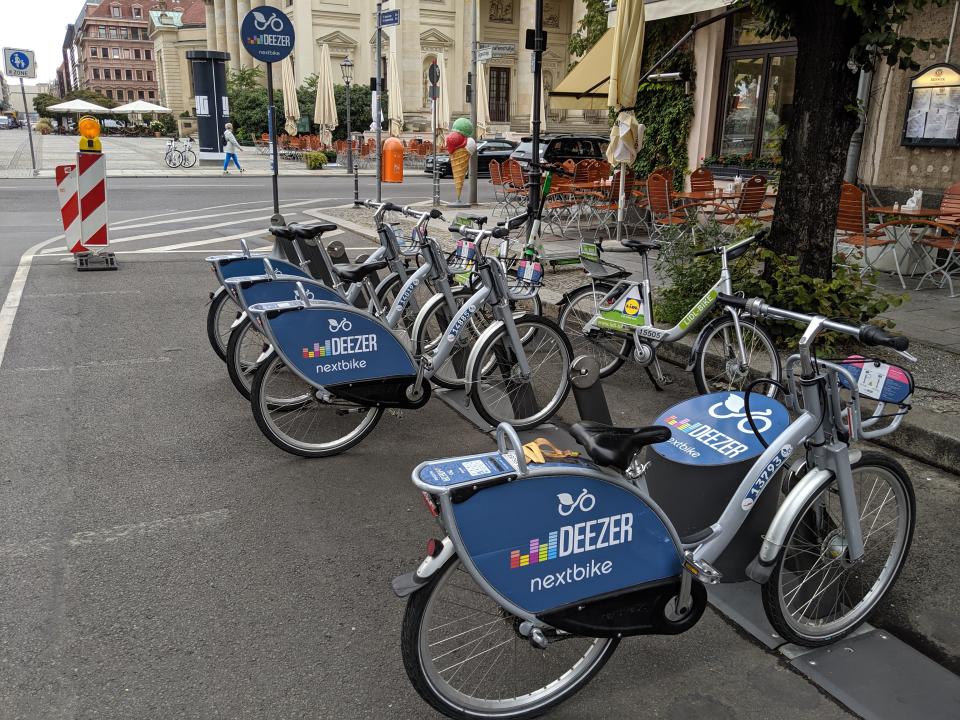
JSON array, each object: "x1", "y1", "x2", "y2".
[{"x1": 743, "y1": 0, "x2": 946, "y2": 280}]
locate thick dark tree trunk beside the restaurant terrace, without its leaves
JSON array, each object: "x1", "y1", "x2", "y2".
[{"x1": 771, "y1": 0, "x2": 860, "y2": 279}]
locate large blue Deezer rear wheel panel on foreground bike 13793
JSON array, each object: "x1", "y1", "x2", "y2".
[{"x1": 452, "y1": 470, "x2": 681, "y2": 614}]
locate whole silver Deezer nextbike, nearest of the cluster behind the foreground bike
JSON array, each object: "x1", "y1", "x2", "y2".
[{"x1": 248, "y1": 222, "x2": 573, "y2": 457}]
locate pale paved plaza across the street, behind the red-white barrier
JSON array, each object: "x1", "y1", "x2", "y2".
[{"x1": 0, "y1": 129, "x2": 374, "y2": 178}]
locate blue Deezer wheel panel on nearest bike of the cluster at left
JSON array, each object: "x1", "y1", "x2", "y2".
[{"x1": 264, "y1": 305, "x2": 417, "y2": 385}]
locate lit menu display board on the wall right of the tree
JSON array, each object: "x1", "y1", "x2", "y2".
[{"x1": 902, "y1": 64, "x2": 960, "y2": 147}]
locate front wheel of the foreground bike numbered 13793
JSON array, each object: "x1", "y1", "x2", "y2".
[{"x1": 762, "y1": 452, "x2": 916, "y2": 647}]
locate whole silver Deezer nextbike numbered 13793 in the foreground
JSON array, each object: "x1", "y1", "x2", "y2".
[{"x1": 393, "y1": 296, "x2": 916, "y2": 719}]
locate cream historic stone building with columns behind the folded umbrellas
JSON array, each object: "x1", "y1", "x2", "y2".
[{"x1": 198, "y1": 0, "x2": 606, "y2": 132}]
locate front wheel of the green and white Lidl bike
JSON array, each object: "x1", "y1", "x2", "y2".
[{"x1": 693, "y1": 315, "x2": 782, "y2": 397}]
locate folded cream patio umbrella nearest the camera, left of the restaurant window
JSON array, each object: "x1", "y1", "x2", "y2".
[{"x1": 607, "y1": 0, "x2": 644, "y2": 242}]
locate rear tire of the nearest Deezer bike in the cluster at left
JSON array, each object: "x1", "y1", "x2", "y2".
[{"x1": 250, "y1": 354, "x2": 383, "y2": 458}]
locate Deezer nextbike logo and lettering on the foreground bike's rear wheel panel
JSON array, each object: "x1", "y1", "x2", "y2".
[{"x1": 510, "y1": 490, "x2": 633, "y2": 592}]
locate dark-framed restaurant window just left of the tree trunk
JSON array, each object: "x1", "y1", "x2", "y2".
[{"x1": 716, "y1": 12, "x2": 797, "y2": 158}]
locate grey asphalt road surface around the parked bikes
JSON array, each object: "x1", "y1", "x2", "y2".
[{"x1": 0, "y1": 177, "x2": 958, "y2": 720}]
